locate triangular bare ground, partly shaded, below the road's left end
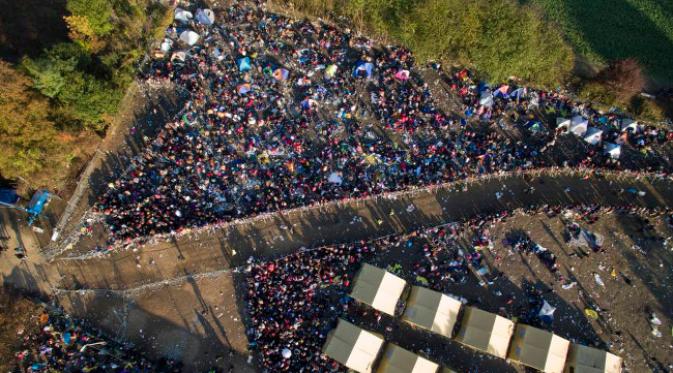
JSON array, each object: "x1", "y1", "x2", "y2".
[{"x1": 57, "y1": 272, "x2": 253, "y2": 372}]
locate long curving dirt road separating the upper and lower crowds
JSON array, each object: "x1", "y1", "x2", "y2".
[{"x1": 48, "y1": 170, "x2": 673, "y2": 289}]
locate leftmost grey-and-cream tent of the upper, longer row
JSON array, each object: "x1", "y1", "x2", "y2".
[{"x1": 351, "y1": 263, "x2": 407, "y2": 316}]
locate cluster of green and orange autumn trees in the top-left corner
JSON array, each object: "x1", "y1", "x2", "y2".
[{"x1": 0, "y1": 0, "x2": 172, "y2": 187}]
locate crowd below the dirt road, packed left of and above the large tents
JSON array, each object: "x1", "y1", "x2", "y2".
[{"x1": 244, "y1": 204, "x2": 670, "y2": 372}]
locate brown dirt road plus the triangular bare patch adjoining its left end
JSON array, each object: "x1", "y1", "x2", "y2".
[{"x1": 0, "y1": 170, "x2": 673, "y2": 371}]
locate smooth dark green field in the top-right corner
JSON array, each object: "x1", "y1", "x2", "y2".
[{"x1": 522, "y1": 0, "x2": 673, "y2": 85}]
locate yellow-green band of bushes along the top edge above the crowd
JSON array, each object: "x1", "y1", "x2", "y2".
[{"x1": 284, "y1": 0, "x2": 574, "y2": 86}]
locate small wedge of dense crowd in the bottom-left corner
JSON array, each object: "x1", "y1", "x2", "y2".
[{"x1": 15, "y1": 311, "x2": 181, "y2": 373}]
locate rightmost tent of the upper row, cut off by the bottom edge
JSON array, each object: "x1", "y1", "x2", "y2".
[{"x1": 565, "y1": 344, "x2": 622, "y2": 373}]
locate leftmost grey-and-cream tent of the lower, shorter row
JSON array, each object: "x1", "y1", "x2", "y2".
[{"x1": 323, "y1": 319, "x2": 383, "y2": 373}]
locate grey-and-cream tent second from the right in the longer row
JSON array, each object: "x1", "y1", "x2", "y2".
[{"x1": 507, "y1": 324, "x2": 570, "y2": 373}]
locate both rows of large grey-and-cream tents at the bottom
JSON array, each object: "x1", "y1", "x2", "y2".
[{"x1": 323, "y1": 264, "x2": 622, "y2": 373}]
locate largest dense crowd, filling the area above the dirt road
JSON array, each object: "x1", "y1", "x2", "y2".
[{"x1": 95, "y1": 2, "x2": 673, "y2": 242}]
